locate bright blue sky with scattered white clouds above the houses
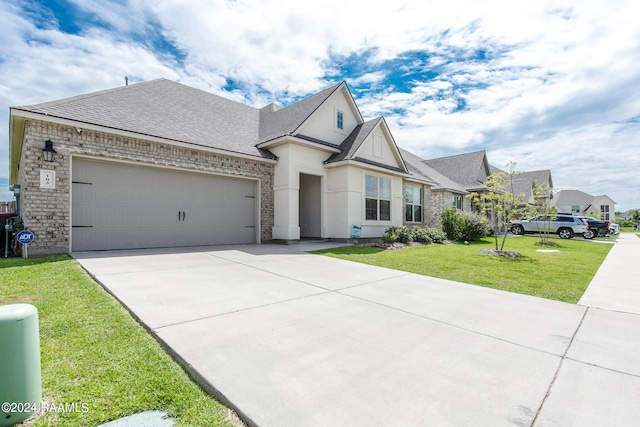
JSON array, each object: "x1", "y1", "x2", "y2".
[{"x1": 0, "y1": 0, "x2": 640, "y2": 211}]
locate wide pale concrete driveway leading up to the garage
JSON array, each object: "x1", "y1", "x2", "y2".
[{"x1": 74, "y1": 245, "x2": 640, "y2": 426}]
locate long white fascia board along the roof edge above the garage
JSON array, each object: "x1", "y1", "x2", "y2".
[{"x1": 11, "y1": 109, "x2": 278, "y2": 164}]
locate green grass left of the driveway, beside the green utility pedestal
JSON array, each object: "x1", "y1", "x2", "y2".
[{"x1": 0, "y1": 256, "x2": 237, "y2": 426}]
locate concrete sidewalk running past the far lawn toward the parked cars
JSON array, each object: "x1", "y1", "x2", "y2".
[{"x1": 578, "y1": 233, "x2": 640, "y2": 314}]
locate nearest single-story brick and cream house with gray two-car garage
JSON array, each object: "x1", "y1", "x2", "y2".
[{"x1": 9, "y1": 79, "x2": 444, "y2": 254}]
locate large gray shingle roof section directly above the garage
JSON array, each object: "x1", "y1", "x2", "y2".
[{"x1": 15, "y1": 79, "x2": 273, "y2": 158}]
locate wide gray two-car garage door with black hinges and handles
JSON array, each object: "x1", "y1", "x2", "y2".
[{"x1": 71, "y1": 158, "x2": 257, "y2": 251}]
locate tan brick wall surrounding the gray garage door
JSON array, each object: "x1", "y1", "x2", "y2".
[{"x1": 18, "y1": 120, "x2": 275, "y2": 255}]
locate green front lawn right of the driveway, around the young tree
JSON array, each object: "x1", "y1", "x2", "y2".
[{"x1": 315, "y1": 236, "x2": 612, "y2": 303}]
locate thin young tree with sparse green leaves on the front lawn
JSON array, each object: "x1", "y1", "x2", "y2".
[{"x1": 467, "y1": 162, "x2": 526, "y2": 251}]
